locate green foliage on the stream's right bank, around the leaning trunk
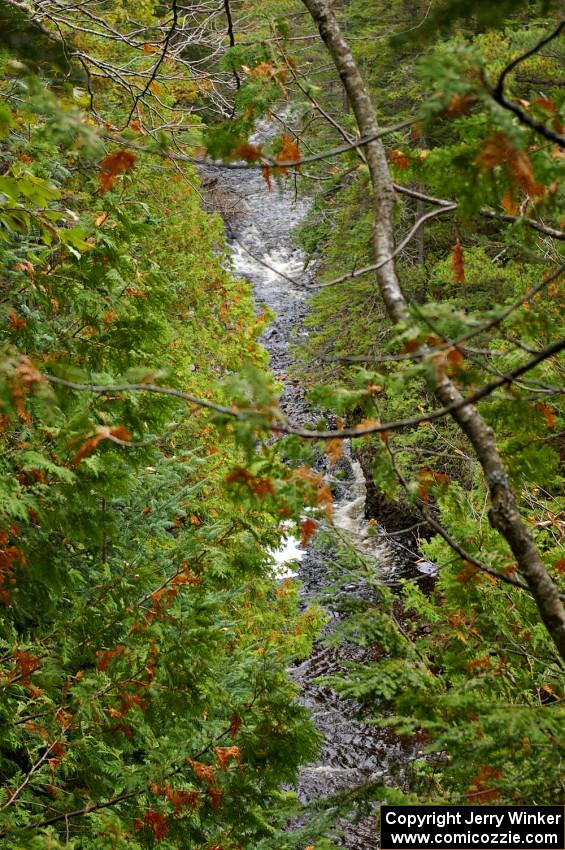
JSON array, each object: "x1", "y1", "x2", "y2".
[{"x1": 286, "y1": 2, "x2": 565, "y2": 803}]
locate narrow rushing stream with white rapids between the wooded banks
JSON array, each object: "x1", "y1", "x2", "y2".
[{"x1": 204, "y1": 125, "x2": 414, "y2": 850}]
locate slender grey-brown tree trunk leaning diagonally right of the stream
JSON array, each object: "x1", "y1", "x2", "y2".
[{"x1": 302, "y1": 0, "x2": 565, "y2": 660}]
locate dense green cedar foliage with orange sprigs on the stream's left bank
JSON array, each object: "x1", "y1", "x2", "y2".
[{"x1": 0, "y1": 21, "x2": 321, "y2": 850}]
